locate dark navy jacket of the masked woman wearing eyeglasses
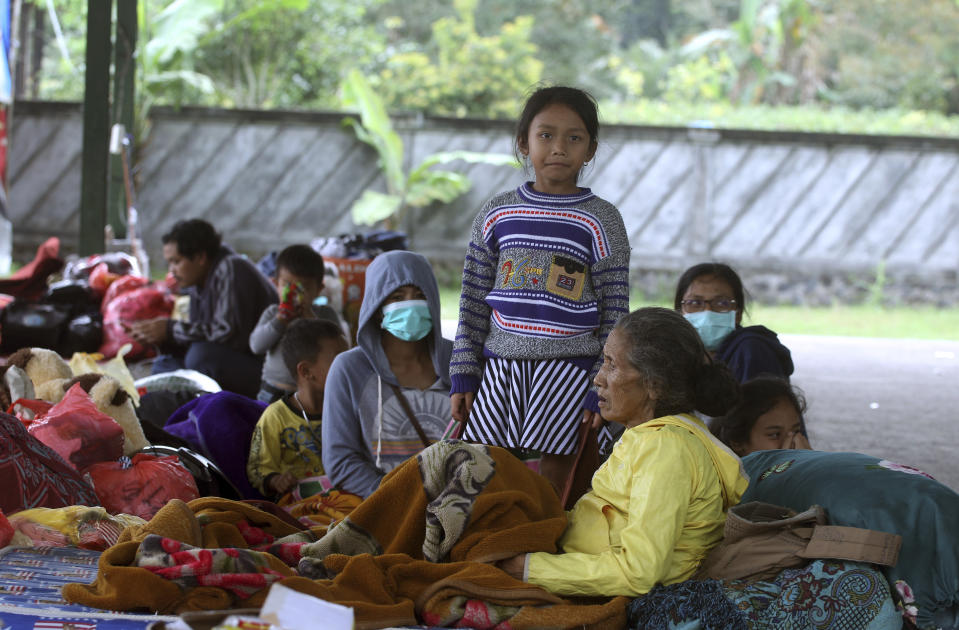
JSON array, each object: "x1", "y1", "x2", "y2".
[{"x1": 716, "y1": 326, "x2": 793, "y2": 383}]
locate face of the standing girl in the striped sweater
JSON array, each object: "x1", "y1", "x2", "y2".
[{"x1": 519, "y1": 103, "x2": 596, "y2": 195}]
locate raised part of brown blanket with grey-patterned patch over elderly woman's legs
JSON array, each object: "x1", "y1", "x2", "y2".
[{"x1": 294, "y1": 440, "x2": 627, "y2": 628}]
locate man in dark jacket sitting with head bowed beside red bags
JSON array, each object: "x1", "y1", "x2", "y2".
[{"x1": 131, "y1": 219, "x2": 278, "y2": 398}]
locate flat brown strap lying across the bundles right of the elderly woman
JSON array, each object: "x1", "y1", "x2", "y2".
[{"x1": 796, "y1": 525, "x2": 902, "y2": 567}]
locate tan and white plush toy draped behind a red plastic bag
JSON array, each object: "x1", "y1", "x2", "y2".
[{"x1": 37, "y1": 374, "x2": 150, "y2": 455}]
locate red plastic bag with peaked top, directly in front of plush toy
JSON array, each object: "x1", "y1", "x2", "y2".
[{"x1": 27, "y1": 383, "x2": 123, "y2": 472}]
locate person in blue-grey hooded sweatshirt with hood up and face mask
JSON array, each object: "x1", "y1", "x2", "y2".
[{"x1": 321, "y1": 251, "x2": 453, "y2": 498}]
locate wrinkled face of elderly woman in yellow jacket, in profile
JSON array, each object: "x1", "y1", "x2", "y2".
[{"x1": 593, "y1": 328, "x2": 655, "y2": 428}]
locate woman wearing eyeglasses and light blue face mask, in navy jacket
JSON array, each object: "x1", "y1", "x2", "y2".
[{"x1": 674, "y1": 263, "x2": 793, "y2": 383}]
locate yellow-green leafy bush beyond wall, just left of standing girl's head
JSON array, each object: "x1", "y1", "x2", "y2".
[{"x1": 376, "y1": 0, "x2": 543, "y2": 118}]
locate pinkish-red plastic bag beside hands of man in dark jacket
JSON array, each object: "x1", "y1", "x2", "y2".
[{"x1": 100, "y1": 287, "x2": 174, "y2": 361}]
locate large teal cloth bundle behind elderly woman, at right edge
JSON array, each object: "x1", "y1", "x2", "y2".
[{"x1": 742, "y1": 450, "x2": 959, "y2": 630}]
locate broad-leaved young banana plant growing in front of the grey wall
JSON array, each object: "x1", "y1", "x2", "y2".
[{"x1": 342, "y1": 70, "x2": 519, "y2": 227}]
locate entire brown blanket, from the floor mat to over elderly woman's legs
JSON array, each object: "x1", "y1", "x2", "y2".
[{"x1": 63, "y1": 441, "x2": 627, "y2": 628}]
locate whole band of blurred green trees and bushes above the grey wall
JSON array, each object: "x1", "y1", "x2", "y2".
[{"x1": 25, "y1": 0, "x2": 959, "y2": 135}]
